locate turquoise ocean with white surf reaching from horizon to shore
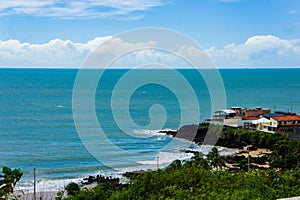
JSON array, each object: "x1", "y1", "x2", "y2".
[{"x1": 0, "y1": 68, "x2": 300, "y2": 191}]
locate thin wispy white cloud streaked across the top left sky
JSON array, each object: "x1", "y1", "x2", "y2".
[{"x1": 0, "y1": 0, "x2": 166, "y2": 19}]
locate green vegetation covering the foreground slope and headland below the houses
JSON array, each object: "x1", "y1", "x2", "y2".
[{"x1": 63, "y1": 127, "x2": 300, "y2": 200}]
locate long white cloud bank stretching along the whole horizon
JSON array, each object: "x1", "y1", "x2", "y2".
[{"x1": 0, "y1": 35, "x2": 300, "y2": 68}]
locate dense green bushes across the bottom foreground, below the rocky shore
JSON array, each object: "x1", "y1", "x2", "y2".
[{"x1": 67, "y1": 152, "x2": 300, "y2": 200}]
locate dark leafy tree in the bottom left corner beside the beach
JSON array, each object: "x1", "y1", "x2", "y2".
[{"x1": 0, "y1": 166, "x2": 23, "y2": 199}]
